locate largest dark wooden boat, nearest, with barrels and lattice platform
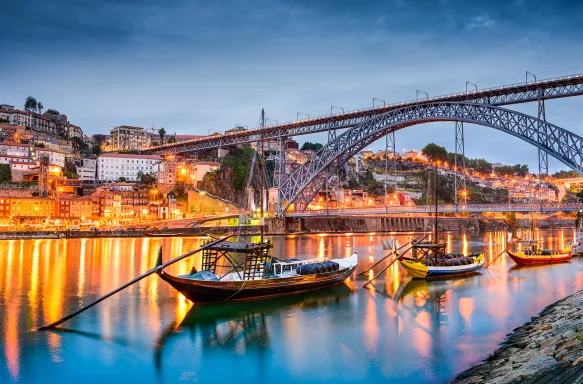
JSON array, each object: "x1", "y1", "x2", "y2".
[{"x1": 158, "y1": 242, "x2": 358, "y2": 303}]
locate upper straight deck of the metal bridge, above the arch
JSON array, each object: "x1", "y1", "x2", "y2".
[{"x1": 142, "y1": 74, "x2": 583, "y2": 155}]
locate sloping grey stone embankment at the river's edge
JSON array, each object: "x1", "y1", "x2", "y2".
[{"x1": 453, "y1": 291, "x2": 583, "y2": 384}]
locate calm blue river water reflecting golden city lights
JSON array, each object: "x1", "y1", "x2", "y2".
[{"x1": 0, "y1": 231, "x2": 583, "y2": 383}]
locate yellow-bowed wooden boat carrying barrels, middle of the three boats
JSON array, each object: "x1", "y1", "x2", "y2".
[{"x1": 399, "y1": 243, "x2": 484, "y2": 279}]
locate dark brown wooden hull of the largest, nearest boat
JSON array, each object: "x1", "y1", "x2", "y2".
[{"x1": 158, "y1": 266, "x2": 356, "y2": 303}]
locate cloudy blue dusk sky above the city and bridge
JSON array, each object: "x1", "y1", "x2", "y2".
[{"x1": 0, "y1": 0, "x2": 583, "y2": 171}]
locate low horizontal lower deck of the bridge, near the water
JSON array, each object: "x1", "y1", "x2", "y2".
[{"x1": 286, "y1": 202, "x2": 583, "y2": 217}]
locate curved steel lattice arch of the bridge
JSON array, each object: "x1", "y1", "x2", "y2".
[{"x1": 278, "y1": 102, "x2": 583, "y2": 215}]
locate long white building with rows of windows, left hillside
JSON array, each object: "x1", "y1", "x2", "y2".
[{"x1": 97, "y1": 153, "x2": 163, "y2": 181}]
